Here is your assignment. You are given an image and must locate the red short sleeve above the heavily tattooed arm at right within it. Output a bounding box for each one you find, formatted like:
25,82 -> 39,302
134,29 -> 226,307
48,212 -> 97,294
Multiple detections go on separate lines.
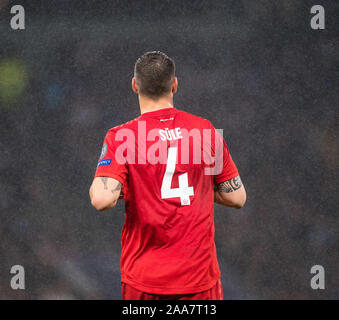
214,126 -> 239,184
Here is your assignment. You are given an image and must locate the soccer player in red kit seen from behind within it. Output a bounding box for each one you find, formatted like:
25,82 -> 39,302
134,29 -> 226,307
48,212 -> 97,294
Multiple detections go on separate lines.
90,51 -> 246,300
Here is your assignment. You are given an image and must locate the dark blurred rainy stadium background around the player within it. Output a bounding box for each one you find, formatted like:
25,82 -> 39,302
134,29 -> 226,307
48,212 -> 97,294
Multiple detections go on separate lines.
0,0 -> 339,299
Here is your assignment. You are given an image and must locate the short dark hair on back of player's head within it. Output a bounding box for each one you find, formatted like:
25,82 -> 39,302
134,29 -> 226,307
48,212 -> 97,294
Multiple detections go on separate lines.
134,51 -> 175,98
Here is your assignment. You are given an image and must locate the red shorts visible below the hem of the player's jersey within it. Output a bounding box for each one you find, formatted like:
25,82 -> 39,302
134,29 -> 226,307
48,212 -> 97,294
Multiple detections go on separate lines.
121,279 -> 223,300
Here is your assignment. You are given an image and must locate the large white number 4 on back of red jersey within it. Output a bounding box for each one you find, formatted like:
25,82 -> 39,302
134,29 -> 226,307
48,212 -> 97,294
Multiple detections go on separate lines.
161,147 -> 194,206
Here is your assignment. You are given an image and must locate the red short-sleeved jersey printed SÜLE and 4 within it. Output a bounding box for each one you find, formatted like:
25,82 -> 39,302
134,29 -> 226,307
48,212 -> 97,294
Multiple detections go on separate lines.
95,108 -> 238,295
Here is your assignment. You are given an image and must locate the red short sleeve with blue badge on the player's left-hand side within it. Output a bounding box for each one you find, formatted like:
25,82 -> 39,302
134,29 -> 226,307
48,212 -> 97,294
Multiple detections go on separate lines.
94,131 -> 128,184
